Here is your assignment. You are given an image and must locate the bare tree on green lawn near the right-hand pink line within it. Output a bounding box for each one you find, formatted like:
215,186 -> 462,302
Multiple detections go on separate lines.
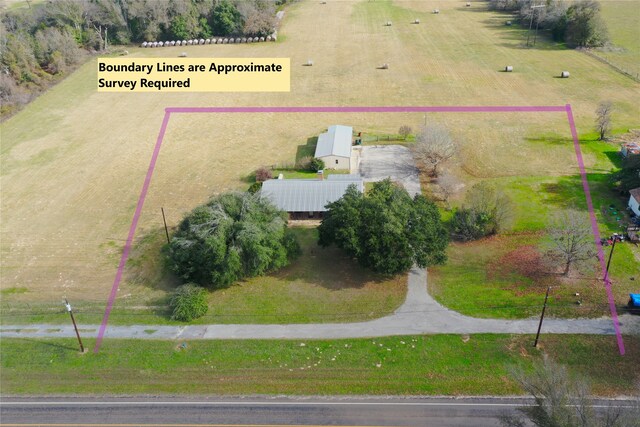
548,211 -> 596,276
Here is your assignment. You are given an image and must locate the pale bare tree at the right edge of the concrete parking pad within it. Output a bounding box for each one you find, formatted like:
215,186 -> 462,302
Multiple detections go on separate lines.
413,124 -> 457,176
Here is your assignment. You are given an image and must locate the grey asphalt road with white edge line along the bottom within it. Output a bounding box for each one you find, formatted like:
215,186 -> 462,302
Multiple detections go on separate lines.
0,396 -> 631,427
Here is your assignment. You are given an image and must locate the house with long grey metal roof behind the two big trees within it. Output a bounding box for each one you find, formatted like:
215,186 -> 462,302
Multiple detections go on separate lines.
260,175 -> 364,219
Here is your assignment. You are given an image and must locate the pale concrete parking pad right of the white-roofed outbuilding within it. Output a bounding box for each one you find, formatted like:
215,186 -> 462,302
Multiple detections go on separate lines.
359,145 -> 420,196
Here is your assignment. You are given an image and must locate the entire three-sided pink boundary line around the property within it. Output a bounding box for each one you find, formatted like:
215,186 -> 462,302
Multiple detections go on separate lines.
93,104 -> 625,355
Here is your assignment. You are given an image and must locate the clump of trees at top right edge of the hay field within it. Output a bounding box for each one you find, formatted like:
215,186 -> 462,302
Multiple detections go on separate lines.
489,0 -> 609,47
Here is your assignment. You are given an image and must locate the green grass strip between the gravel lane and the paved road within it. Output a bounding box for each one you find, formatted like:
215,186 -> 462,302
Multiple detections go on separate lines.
0,335 -> 640,396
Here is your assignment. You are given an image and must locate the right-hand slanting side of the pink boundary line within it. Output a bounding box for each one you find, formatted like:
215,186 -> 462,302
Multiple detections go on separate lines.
565,104 -> 625,355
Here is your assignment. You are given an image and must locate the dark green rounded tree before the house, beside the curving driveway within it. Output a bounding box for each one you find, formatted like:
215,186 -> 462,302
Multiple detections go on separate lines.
318,179 -> 448,274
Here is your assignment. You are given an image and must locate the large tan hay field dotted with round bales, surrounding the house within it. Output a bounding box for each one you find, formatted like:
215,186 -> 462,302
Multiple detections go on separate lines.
0,1 -> 640,316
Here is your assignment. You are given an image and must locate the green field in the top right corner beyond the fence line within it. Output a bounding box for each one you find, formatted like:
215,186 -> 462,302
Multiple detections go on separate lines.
598,0 -> 640,77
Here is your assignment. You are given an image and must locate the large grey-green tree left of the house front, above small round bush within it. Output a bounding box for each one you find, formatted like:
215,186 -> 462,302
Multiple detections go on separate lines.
168,193 -> 299,288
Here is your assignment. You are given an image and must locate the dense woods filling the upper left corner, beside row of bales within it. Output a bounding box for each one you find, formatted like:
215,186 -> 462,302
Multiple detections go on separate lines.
0,0 -> 287,116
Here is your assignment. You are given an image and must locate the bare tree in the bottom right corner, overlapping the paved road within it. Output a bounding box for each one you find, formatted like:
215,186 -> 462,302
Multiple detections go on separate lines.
500,356 -> 640,427
